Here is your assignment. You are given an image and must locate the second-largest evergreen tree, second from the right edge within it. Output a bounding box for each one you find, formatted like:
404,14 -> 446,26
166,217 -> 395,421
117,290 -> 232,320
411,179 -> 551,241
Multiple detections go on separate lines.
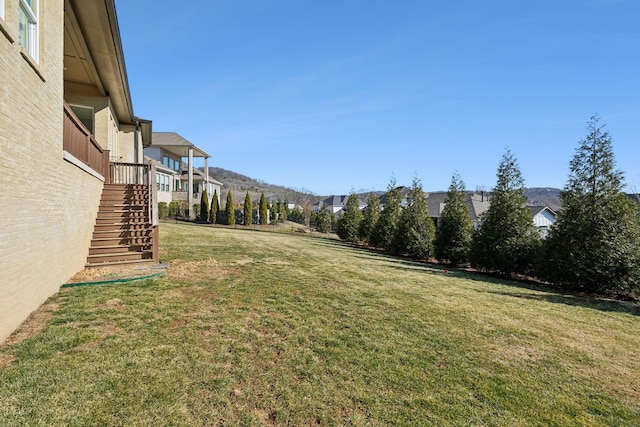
470,150 -> 540,276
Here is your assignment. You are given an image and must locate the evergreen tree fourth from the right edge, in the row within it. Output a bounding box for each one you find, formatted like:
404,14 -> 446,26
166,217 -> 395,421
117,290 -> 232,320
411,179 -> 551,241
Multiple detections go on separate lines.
393,177 -> 436,258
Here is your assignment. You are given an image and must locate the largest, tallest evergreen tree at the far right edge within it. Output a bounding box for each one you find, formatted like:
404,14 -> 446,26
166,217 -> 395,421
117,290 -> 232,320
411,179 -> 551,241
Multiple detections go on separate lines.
540,117 -> 640,294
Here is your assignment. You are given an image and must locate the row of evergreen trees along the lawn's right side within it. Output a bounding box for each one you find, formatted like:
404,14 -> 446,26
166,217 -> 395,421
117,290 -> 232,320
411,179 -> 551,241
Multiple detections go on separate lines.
337,117 -> 640,295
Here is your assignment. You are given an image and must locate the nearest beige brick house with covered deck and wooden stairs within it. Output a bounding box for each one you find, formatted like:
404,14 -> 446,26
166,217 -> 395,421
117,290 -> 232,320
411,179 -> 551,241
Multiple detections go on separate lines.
0,0 -> 157,342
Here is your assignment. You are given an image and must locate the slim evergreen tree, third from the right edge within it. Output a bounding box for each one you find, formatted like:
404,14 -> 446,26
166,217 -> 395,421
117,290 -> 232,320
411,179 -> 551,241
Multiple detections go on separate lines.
435,173 -> 473,265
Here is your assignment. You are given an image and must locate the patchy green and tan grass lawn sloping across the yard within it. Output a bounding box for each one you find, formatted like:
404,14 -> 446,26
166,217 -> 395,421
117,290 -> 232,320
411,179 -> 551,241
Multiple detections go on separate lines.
0,223 -> 640,426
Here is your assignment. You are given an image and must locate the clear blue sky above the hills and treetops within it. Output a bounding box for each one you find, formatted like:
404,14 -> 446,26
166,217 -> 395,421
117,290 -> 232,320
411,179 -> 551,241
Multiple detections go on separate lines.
116,0 -> 640,195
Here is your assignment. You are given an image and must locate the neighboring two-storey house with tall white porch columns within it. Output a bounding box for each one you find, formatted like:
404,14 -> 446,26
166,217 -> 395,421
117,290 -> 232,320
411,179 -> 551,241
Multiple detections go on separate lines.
144,132 -> 222,218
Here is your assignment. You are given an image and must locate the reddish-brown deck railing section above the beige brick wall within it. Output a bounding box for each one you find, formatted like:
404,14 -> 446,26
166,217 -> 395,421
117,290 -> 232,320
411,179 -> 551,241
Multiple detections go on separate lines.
62,102 -> 109,179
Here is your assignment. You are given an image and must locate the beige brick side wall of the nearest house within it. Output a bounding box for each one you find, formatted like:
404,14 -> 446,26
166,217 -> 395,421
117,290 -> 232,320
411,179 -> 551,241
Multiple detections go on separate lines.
0,0 -> 103,342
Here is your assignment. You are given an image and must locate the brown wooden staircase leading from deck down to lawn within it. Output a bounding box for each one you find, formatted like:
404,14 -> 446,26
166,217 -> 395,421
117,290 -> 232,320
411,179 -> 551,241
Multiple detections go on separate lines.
87,184 -> 158,267
